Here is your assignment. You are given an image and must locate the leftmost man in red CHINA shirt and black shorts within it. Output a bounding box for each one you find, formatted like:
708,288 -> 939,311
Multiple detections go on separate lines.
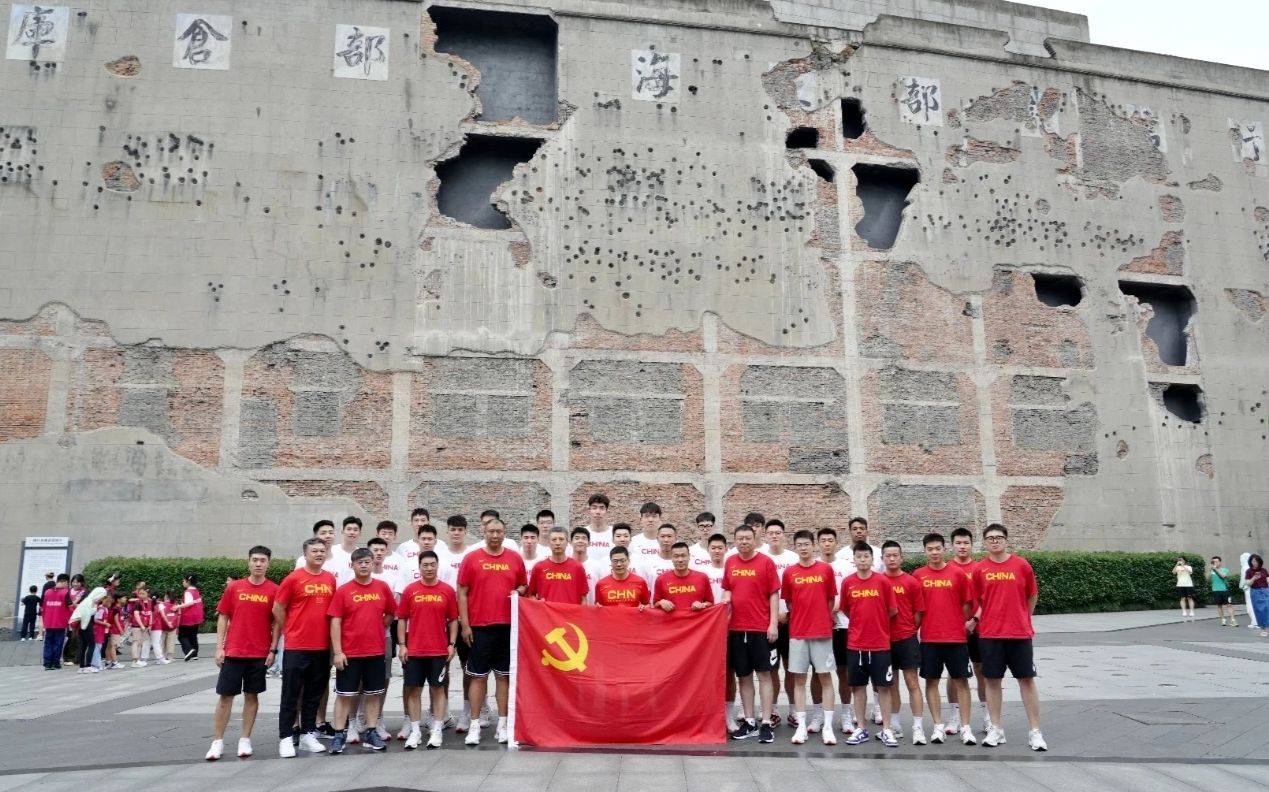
206,545 -> 280,762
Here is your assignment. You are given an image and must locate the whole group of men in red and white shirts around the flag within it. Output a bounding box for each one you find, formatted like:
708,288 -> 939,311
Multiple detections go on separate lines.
206,494 -> 1047,760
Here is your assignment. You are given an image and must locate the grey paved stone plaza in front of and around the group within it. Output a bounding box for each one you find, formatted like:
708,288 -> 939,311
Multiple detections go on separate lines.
0,611 -> 1269,792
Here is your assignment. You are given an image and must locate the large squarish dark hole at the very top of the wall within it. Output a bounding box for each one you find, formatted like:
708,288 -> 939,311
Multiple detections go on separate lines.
428,5 -> 556,124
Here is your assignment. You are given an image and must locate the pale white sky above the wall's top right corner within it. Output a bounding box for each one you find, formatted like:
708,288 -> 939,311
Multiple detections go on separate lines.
1040,0 -> 1269,70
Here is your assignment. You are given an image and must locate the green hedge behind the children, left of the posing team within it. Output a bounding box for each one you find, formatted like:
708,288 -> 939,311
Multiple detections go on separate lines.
84,556 -> 294,632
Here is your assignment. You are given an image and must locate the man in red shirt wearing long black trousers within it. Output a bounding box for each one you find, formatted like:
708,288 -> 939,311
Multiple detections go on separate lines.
273,537 -> 335,759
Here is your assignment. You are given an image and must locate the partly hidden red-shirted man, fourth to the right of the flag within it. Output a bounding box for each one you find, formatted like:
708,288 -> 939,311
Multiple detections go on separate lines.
881,539 -> 925,745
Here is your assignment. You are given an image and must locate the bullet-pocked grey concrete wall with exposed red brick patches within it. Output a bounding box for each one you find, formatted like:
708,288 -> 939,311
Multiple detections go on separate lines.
0,0 -> 1269,611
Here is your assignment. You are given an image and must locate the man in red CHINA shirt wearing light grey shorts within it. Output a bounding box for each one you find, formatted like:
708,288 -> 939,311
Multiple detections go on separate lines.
780,529 -> 838,745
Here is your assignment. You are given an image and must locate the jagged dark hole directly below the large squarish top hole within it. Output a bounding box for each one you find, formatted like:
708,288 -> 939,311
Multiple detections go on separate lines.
437,135 -> 542,228
